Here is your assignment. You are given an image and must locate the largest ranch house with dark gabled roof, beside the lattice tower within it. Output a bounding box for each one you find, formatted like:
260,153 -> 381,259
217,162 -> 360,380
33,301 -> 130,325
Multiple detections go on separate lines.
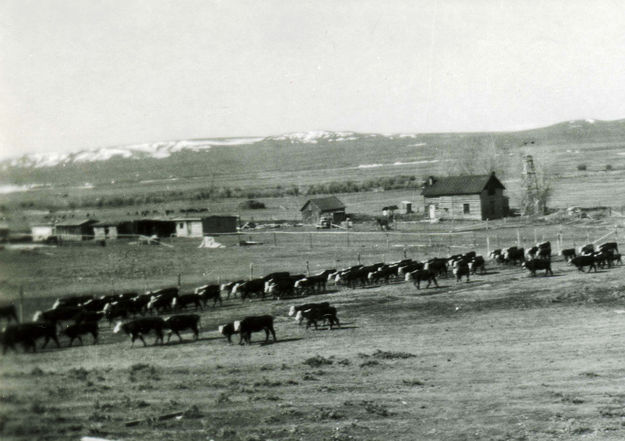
421,173 -> 508,220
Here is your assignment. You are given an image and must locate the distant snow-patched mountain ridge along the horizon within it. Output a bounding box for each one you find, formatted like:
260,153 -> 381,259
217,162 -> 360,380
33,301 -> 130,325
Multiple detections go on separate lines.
0,119 -> 625,184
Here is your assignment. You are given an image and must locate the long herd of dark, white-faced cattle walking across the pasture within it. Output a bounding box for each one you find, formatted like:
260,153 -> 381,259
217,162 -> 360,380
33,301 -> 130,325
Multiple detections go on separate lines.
0,242 -> 622,353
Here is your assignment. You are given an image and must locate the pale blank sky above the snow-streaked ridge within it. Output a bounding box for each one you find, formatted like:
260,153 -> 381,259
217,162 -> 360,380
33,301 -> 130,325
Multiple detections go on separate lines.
0,0 -> 625,157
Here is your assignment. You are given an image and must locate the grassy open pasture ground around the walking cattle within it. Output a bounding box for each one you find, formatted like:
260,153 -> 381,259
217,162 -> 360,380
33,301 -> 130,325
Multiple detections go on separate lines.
0,223 -> 625,441
